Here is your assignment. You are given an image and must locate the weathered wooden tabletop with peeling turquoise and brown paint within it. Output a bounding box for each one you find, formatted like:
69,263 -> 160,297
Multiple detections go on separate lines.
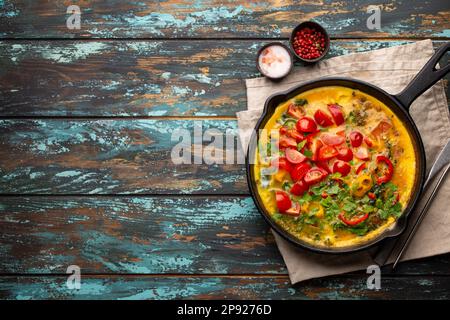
0,0 -> 450,299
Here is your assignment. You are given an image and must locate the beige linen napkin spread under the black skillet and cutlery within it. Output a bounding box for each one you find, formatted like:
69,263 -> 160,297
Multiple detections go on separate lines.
237,40 -> 450,283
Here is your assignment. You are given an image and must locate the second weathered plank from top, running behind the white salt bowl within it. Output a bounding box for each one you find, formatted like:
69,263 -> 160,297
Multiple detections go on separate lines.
0,40 -> 450,117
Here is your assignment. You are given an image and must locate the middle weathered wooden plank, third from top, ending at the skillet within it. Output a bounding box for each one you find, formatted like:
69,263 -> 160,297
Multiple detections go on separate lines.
0,120 -> 248,194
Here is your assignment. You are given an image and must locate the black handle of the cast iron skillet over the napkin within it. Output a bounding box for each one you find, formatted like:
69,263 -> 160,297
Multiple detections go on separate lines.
395,42 -> 450,110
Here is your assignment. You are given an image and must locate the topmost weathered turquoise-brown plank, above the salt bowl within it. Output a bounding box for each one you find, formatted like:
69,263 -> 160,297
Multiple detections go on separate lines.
0,0 -> 450,38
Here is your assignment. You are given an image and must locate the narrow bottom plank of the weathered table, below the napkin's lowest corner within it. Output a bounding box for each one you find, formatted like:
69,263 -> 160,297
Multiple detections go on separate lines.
0,275 -> 450,300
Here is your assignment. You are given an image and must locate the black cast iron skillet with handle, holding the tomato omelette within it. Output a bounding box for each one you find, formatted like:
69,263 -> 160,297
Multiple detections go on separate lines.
246,43 -> 450,253
